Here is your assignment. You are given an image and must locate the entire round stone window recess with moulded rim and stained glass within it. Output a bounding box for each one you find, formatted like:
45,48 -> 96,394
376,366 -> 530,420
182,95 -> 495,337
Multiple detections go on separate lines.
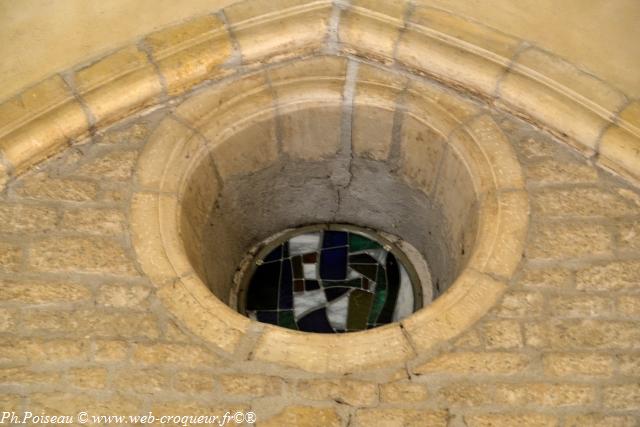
131,57 -> 529,373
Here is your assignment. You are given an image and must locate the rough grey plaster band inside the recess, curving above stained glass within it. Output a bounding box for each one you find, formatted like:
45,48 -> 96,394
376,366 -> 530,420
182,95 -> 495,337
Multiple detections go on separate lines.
199,159 -> 460,308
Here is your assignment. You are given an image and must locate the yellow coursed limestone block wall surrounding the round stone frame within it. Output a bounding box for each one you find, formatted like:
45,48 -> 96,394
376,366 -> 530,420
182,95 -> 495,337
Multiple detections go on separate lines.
0,84 -> 640,426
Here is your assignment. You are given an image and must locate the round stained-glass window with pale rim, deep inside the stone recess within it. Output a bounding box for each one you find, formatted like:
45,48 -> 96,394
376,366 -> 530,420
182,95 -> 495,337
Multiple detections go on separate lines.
238,224 -> 423,333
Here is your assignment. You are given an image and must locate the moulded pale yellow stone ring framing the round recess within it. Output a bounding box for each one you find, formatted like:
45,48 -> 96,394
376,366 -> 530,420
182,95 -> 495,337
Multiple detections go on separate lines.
130,57 -> 529,373
